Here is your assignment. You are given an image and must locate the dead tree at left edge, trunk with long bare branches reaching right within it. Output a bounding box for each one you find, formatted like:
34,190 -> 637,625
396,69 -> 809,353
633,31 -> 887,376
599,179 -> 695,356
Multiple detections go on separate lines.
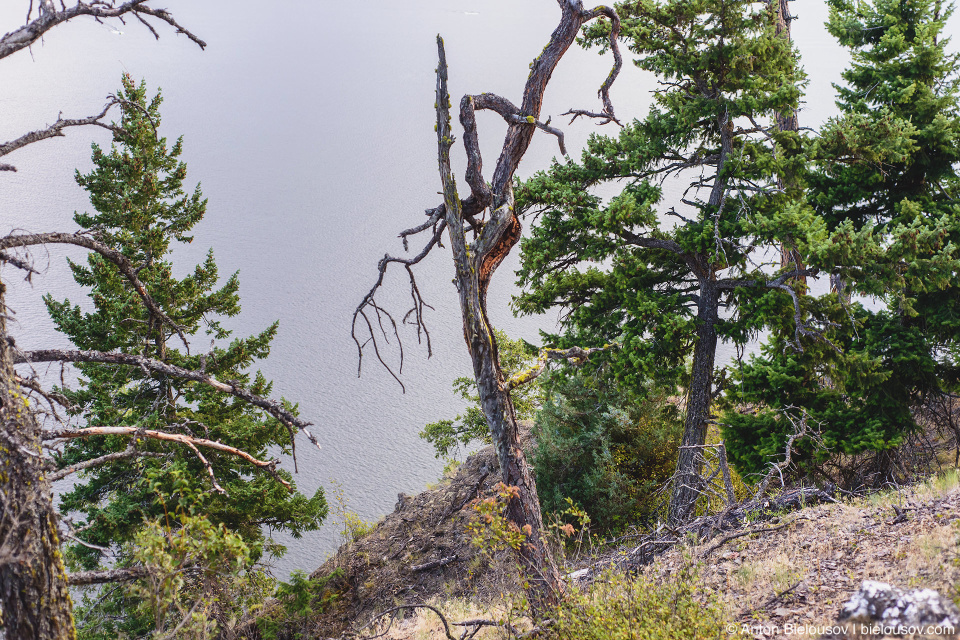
0,6 -> 318,640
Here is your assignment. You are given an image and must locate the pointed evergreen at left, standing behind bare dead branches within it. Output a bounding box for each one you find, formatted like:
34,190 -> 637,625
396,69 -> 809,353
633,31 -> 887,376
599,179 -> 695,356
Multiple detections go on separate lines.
45,76 -> 327,637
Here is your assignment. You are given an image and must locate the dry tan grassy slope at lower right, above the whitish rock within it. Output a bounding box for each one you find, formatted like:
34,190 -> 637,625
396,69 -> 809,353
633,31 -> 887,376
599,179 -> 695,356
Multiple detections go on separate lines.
646,470 -> 960,637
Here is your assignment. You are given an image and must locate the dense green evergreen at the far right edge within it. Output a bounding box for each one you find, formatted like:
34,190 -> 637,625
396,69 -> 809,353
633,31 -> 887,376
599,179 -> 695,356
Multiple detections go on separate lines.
723,0 -> 960,482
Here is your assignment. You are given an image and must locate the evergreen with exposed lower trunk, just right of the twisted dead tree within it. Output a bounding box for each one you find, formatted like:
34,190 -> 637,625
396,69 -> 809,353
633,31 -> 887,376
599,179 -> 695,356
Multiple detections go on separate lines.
516,0 -> 822,520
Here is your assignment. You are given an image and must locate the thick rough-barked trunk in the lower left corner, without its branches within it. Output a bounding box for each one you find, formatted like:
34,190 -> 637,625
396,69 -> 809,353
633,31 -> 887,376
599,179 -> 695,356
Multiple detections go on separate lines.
0,282 -> 76,640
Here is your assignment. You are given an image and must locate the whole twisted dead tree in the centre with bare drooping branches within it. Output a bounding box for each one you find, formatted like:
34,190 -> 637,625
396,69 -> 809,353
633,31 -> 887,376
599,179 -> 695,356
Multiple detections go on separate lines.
353,0 -> 621,611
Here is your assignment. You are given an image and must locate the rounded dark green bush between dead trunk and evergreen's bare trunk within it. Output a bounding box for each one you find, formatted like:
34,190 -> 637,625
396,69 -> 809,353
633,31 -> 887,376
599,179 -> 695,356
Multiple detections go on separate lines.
532,374 -> 683,533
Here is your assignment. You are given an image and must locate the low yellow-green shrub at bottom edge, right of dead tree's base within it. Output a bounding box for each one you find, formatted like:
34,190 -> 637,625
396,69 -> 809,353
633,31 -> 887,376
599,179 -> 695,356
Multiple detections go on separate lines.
542,565 -> 743,640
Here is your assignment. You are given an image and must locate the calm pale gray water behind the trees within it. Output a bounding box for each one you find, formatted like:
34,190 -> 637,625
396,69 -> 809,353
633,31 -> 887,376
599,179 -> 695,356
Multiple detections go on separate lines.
0,0 -> 928,575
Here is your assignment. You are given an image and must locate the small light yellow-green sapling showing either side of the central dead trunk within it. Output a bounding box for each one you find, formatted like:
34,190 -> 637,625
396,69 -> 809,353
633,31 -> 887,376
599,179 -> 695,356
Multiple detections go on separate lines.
420,329 -> 541,458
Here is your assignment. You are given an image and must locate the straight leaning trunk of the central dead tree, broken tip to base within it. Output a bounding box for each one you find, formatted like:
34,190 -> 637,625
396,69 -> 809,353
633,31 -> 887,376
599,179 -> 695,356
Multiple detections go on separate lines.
437,38 -> 563,612
